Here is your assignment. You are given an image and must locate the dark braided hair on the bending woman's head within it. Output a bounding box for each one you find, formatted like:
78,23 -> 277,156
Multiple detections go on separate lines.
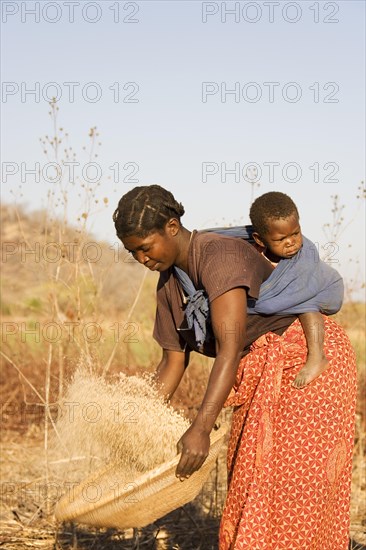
113,185 -> 184,239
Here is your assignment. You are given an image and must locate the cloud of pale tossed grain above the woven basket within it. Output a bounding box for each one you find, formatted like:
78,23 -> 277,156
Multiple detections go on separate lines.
54,368 -> 189,481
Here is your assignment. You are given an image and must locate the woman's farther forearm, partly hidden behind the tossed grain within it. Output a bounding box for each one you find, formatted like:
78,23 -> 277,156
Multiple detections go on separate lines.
154,349 -> 189,400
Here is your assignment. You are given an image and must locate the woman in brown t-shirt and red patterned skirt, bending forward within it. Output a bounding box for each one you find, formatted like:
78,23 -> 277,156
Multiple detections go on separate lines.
113,185 -> 356,550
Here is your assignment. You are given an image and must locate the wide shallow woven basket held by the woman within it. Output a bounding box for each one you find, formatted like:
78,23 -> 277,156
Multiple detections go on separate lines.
55,424 -> 228,529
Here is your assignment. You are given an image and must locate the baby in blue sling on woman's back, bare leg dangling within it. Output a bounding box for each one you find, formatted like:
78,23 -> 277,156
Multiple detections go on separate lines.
249,191 -> 343,388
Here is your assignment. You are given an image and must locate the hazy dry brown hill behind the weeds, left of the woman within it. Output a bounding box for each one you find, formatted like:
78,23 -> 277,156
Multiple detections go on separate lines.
0,205 -> 149,320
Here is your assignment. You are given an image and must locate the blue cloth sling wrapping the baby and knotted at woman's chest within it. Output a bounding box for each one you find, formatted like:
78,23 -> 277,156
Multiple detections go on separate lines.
174,226 -> 344,347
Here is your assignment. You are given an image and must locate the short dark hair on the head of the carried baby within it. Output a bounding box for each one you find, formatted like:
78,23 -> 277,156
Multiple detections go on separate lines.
249,191 -> 299,236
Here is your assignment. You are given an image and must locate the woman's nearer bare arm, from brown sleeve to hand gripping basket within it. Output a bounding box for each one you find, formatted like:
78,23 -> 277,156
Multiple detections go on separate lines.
176,288 -> 247,479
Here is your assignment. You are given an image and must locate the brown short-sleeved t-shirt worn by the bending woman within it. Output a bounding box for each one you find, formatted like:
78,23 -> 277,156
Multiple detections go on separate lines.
153,231 -> 296,357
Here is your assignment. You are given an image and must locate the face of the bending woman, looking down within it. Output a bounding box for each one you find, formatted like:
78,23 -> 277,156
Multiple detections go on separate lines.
122,224 -> 178,271
